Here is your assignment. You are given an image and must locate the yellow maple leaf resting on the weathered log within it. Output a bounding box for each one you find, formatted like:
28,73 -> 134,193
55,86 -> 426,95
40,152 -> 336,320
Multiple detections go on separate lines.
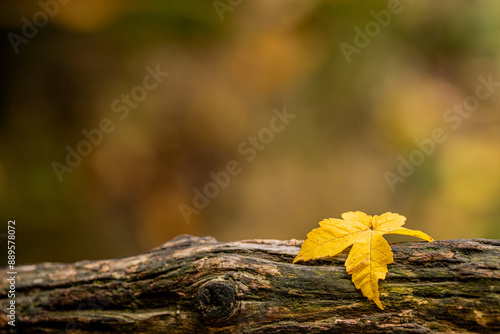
293,211 -> 434,310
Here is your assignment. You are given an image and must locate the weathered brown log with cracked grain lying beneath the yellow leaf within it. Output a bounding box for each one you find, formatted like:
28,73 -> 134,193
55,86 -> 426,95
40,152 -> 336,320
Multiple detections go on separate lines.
0,236 -> 500,333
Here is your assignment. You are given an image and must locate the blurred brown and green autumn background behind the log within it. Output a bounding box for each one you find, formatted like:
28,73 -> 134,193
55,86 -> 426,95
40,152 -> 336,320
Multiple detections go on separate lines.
0,0 -> 500,264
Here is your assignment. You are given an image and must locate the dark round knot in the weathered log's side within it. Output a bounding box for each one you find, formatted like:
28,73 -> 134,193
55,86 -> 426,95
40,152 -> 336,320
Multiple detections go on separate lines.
198,280 -> 235,322
